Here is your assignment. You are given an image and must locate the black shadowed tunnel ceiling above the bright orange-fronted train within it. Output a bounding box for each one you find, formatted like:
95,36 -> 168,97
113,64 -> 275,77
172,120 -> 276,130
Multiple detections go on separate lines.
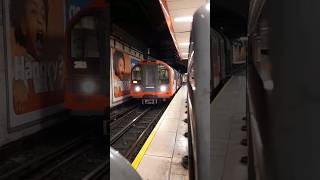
110,0 -> 185,70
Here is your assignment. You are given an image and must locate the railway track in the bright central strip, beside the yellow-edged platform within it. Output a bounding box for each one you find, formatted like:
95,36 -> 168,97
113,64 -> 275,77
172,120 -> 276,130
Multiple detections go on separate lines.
110,103 -> 168,161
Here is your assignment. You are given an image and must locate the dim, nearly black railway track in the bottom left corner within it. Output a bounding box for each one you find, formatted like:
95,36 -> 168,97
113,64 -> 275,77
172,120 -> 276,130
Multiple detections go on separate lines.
0,121 -> 109,180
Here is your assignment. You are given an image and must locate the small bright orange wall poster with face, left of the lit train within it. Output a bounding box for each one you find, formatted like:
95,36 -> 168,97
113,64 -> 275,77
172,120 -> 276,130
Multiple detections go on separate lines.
111,48 -> 131,102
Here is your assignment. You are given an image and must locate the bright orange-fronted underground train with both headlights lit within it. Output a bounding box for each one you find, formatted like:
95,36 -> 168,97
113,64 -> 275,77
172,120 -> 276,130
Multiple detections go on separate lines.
130,60 -> 182,104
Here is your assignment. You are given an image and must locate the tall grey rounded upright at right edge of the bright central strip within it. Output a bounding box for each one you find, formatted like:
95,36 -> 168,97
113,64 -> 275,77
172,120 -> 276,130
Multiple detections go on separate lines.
187,3 -> 211,180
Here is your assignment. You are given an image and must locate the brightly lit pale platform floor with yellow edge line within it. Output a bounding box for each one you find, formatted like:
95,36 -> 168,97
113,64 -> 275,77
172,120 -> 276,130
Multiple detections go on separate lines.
133,85 -> 188,180
